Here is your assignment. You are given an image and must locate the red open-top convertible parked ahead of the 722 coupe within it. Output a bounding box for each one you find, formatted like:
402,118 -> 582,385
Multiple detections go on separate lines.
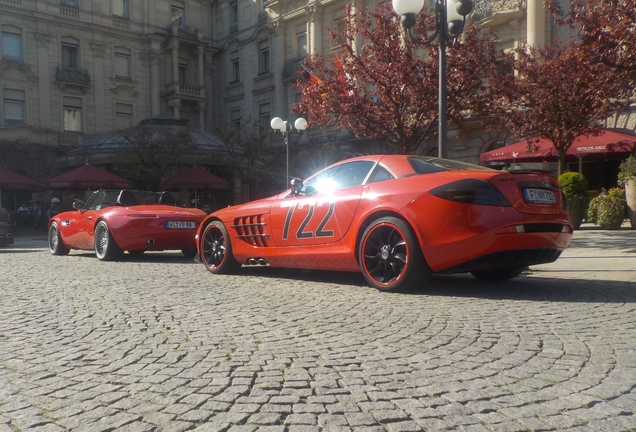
49,189 -> 205,261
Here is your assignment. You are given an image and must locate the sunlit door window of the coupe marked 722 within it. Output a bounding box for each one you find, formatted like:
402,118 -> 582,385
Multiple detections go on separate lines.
300,161 -> 375,195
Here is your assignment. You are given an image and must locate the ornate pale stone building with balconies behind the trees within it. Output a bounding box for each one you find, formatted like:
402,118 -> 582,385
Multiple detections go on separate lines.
0,0 -> 636,187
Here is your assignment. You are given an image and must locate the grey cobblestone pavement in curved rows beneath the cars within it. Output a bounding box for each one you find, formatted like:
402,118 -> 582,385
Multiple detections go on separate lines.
0,224 -> 636,432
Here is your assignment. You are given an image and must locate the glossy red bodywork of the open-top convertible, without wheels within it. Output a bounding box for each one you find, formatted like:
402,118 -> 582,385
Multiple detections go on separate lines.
49,191 -> 206,255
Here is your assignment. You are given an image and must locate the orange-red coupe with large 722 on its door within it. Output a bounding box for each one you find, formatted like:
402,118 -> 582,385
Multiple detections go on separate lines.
196,155 -> 572,291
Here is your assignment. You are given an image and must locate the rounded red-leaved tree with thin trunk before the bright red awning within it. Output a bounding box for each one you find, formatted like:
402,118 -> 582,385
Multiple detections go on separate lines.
490,42 -> 622,175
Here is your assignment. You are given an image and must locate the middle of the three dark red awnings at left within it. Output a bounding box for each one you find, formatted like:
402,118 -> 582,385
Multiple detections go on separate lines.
46,164 -> 132,189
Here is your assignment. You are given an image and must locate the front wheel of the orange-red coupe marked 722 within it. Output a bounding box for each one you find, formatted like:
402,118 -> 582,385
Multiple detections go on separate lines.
200,221 -> 241,274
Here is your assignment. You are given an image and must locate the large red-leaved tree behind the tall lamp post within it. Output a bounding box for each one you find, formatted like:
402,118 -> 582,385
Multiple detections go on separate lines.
292,2 -> 499,154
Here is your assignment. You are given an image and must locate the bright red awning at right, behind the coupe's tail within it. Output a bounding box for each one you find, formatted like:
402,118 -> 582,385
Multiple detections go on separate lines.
479,130 -> 636,162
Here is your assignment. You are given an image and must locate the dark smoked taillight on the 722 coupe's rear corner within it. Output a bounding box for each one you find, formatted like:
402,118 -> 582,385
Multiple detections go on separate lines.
430,179 -> 512,207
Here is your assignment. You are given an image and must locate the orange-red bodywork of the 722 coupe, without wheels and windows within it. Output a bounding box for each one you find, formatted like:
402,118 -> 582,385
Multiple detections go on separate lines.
197,155 -> 572,272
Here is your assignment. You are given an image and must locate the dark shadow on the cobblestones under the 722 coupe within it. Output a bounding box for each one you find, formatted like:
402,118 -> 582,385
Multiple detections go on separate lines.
238,267 -> 636,304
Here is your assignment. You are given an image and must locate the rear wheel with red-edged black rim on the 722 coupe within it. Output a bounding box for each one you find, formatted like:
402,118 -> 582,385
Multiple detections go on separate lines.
358,216 -> 432,292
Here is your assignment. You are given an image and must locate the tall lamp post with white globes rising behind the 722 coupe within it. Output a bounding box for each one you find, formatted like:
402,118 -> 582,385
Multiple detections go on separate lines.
393,0 -> 474,158
